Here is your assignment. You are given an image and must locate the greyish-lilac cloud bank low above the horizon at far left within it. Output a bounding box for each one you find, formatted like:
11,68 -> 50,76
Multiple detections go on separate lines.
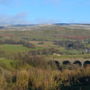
0,12 -> 30,25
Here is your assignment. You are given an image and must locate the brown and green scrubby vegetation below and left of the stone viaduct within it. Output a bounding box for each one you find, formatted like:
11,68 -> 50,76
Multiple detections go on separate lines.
0,46 -> 90,90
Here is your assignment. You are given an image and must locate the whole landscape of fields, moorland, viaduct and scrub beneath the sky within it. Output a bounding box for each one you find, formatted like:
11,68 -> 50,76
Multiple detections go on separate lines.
0,25 -> 90,90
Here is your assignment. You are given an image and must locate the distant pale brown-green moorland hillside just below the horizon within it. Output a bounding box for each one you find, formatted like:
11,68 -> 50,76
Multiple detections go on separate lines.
0,25 -> 90,41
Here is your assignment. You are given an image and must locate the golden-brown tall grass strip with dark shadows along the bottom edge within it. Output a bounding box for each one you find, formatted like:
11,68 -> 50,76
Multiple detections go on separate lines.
0,65 -> 90,90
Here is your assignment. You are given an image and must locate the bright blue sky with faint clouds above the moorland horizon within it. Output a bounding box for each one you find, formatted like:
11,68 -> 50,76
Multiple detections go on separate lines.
0,0 -> 90,24
